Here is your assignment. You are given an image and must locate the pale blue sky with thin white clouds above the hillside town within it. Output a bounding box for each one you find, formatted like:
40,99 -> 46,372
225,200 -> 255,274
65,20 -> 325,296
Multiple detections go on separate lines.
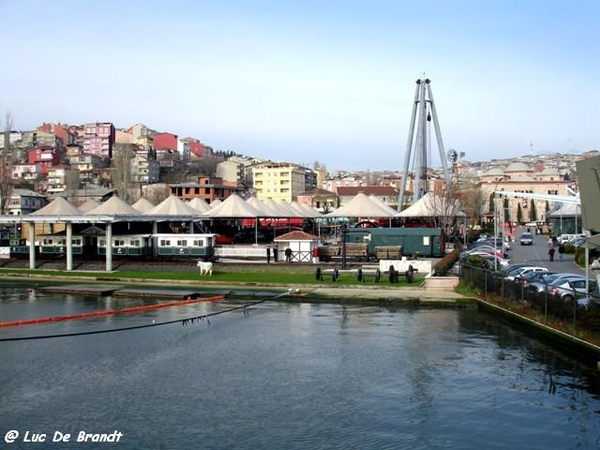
0,0 -> 600,171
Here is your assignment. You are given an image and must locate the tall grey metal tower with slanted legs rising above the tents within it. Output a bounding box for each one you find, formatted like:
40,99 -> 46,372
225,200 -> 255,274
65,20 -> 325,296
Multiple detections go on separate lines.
398,78 -> 451,211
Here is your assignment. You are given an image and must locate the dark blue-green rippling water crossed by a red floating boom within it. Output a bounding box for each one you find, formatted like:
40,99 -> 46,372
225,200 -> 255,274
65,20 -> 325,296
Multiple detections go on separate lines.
0,288 -> 600,450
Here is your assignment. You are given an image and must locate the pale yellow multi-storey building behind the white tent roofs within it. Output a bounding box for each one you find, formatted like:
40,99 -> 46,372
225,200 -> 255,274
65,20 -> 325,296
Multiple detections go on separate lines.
252,162 -> 306,202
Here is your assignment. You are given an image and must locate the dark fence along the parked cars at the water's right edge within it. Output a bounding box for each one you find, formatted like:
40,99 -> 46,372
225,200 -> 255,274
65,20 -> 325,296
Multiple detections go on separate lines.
459,264 -> 600,332
